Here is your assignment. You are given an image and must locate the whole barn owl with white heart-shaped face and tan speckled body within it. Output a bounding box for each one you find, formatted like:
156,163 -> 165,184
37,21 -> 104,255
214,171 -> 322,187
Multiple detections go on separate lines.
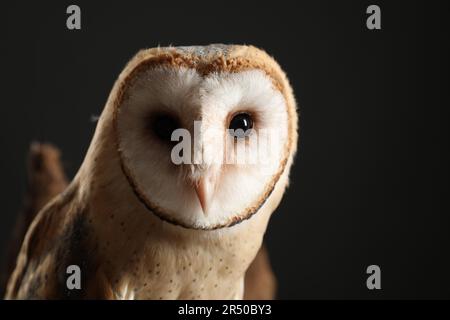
6,45 -> 298,299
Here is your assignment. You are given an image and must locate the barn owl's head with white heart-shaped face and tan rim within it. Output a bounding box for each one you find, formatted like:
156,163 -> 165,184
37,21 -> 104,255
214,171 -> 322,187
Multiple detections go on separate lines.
89,45 -> 297,230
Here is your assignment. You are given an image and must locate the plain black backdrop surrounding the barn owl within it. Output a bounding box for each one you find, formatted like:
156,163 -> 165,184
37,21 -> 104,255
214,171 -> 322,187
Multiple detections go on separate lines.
0,0 -> 450,298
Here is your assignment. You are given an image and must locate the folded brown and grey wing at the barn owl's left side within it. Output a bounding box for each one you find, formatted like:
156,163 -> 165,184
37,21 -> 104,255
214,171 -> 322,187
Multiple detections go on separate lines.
6,184 -> 114,299
